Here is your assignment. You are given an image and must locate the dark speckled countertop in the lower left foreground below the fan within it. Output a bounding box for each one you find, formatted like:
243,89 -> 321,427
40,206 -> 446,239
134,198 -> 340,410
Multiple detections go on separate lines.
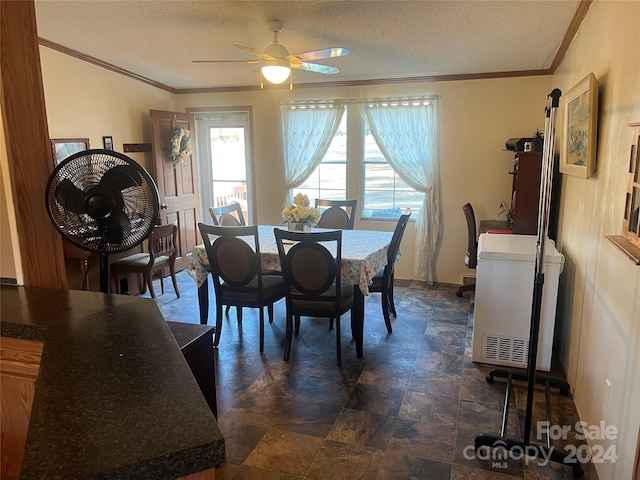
0,286 -> 225,480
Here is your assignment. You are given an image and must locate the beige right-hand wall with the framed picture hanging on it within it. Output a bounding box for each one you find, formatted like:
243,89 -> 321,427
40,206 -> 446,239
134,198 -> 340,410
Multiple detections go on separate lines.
553,1 -> 640,479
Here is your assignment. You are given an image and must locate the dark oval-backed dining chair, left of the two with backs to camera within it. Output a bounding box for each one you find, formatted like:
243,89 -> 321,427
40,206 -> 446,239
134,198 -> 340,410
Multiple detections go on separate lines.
198,223 -> 284,353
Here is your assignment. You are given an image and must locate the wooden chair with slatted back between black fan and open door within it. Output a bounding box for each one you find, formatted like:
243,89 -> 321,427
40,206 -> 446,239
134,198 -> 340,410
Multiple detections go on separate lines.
109,223 -> 180,298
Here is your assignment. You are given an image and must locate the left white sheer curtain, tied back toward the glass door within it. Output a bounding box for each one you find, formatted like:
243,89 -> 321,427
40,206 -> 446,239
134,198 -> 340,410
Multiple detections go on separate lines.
280,102 -> 345,206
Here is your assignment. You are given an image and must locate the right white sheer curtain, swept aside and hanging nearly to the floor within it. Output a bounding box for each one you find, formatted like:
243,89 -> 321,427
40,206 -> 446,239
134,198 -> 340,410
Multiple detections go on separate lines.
362,97 -> 442,284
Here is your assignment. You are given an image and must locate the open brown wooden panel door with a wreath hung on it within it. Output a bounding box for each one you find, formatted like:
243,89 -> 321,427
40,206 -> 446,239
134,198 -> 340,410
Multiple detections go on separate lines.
150,110 -> 200,270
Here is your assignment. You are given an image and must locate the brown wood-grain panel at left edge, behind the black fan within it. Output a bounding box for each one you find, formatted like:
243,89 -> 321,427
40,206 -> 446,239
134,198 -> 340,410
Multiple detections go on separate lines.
0,0 -> 67,288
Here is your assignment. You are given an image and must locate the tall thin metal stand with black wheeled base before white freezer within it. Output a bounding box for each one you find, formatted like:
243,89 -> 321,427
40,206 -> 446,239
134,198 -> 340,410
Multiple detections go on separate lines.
475,88 -> 584,477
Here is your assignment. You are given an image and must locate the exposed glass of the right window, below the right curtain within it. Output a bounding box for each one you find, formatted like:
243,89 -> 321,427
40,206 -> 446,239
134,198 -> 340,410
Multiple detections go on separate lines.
361,120 -> 424,219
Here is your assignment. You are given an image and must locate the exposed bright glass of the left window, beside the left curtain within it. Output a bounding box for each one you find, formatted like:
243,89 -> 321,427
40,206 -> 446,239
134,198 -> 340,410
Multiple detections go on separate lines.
296,115 -> 347,203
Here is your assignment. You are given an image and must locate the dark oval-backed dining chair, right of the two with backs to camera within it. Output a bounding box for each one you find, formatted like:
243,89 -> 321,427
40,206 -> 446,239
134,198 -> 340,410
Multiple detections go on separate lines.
274,228 -> 354,365
